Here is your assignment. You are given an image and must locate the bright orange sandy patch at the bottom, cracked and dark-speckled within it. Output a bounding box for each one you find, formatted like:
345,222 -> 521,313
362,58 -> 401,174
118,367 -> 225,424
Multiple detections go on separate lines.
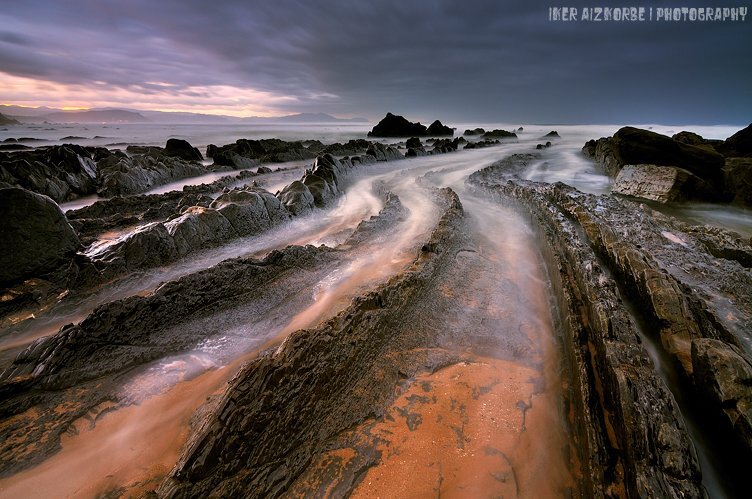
353,358 -> 571,497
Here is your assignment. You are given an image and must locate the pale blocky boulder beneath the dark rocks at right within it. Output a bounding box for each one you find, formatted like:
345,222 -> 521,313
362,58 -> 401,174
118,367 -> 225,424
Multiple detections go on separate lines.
612,165 -> 711,203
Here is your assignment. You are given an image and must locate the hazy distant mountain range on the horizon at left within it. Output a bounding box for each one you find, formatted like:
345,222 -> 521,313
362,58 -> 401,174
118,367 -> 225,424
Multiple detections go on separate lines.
0,105 -> 368,125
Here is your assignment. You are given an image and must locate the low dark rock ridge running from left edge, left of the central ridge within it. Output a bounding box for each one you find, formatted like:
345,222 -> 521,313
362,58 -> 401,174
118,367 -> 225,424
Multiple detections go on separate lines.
0,186 -> 406,476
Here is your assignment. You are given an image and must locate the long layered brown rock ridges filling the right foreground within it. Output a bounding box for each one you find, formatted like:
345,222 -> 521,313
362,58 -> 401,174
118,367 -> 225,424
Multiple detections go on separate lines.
471,158 -> 752,497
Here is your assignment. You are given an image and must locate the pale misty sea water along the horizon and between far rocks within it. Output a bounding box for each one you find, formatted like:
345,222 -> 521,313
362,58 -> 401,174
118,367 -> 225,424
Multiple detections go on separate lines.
0,122 -> 752,237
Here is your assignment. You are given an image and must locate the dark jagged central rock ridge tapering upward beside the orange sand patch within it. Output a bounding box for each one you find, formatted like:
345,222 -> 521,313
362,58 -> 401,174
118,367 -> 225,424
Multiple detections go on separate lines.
157,189 -> 463,497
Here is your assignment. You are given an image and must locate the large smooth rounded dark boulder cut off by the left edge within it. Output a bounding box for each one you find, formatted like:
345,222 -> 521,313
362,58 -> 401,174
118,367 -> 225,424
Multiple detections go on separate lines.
0,187 -> 80,284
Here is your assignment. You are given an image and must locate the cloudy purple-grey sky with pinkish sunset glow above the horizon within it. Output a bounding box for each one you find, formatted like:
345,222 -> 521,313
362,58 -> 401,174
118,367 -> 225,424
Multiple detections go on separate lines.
0,0 -> 752,125
